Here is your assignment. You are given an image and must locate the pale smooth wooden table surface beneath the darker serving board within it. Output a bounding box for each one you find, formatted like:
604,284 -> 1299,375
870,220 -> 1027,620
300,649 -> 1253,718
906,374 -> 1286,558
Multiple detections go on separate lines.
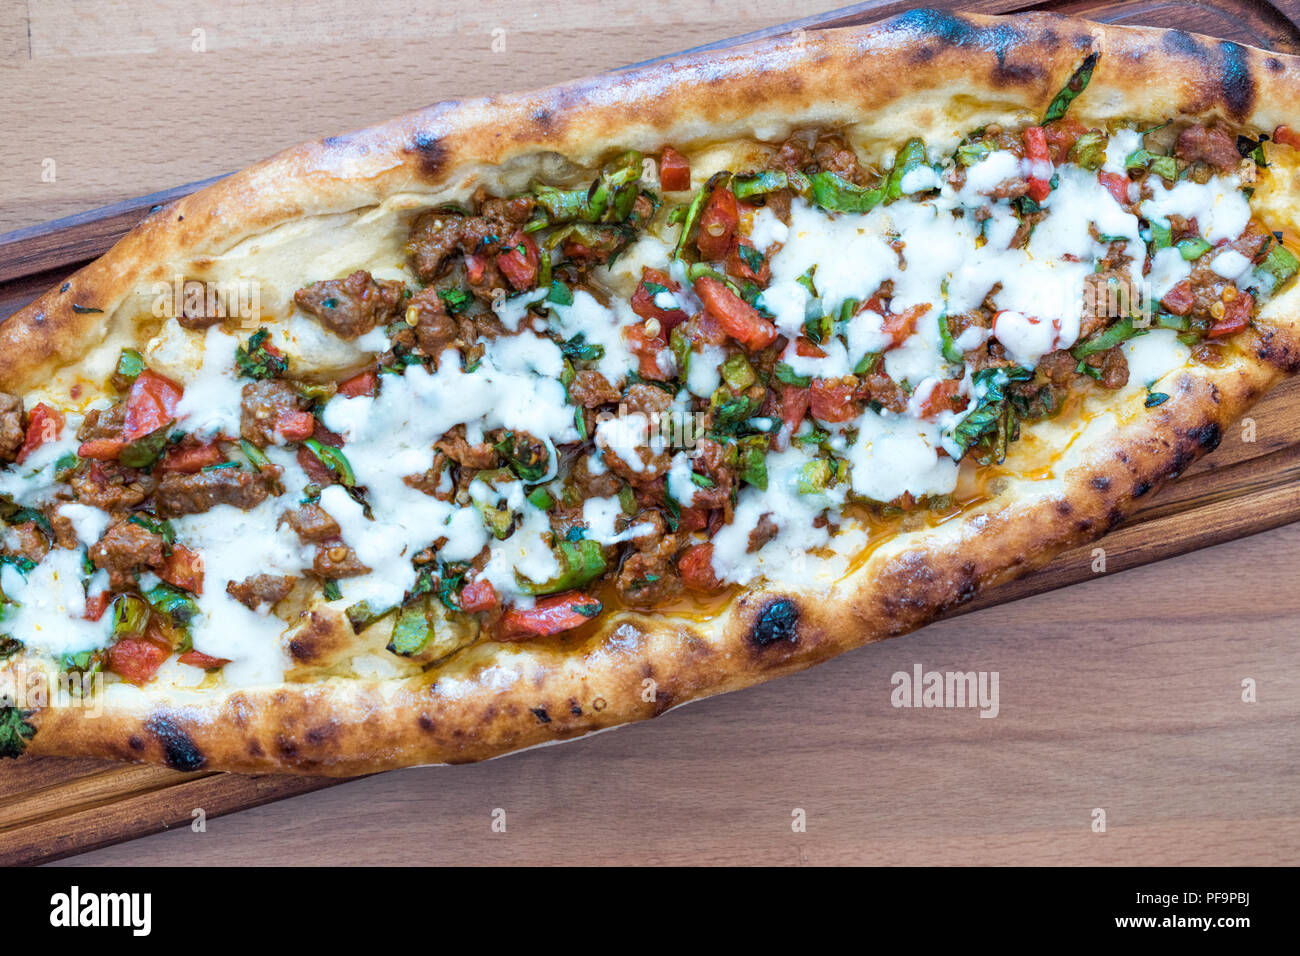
0,0 -> 1300,865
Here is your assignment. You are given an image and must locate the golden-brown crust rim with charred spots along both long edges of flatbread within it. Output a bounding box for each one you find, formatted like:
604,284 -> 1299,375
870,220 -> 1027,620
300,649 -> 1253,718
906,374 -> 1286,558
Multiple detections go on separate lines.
0,12 -> 1300,775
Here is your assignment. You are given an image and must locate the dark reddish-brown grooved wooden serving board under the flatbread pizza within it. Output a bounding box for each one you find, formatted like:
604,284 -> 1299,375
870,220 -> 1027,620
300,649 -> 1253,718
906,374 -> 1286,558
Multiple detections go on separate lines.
0,0 -> 1300,865
